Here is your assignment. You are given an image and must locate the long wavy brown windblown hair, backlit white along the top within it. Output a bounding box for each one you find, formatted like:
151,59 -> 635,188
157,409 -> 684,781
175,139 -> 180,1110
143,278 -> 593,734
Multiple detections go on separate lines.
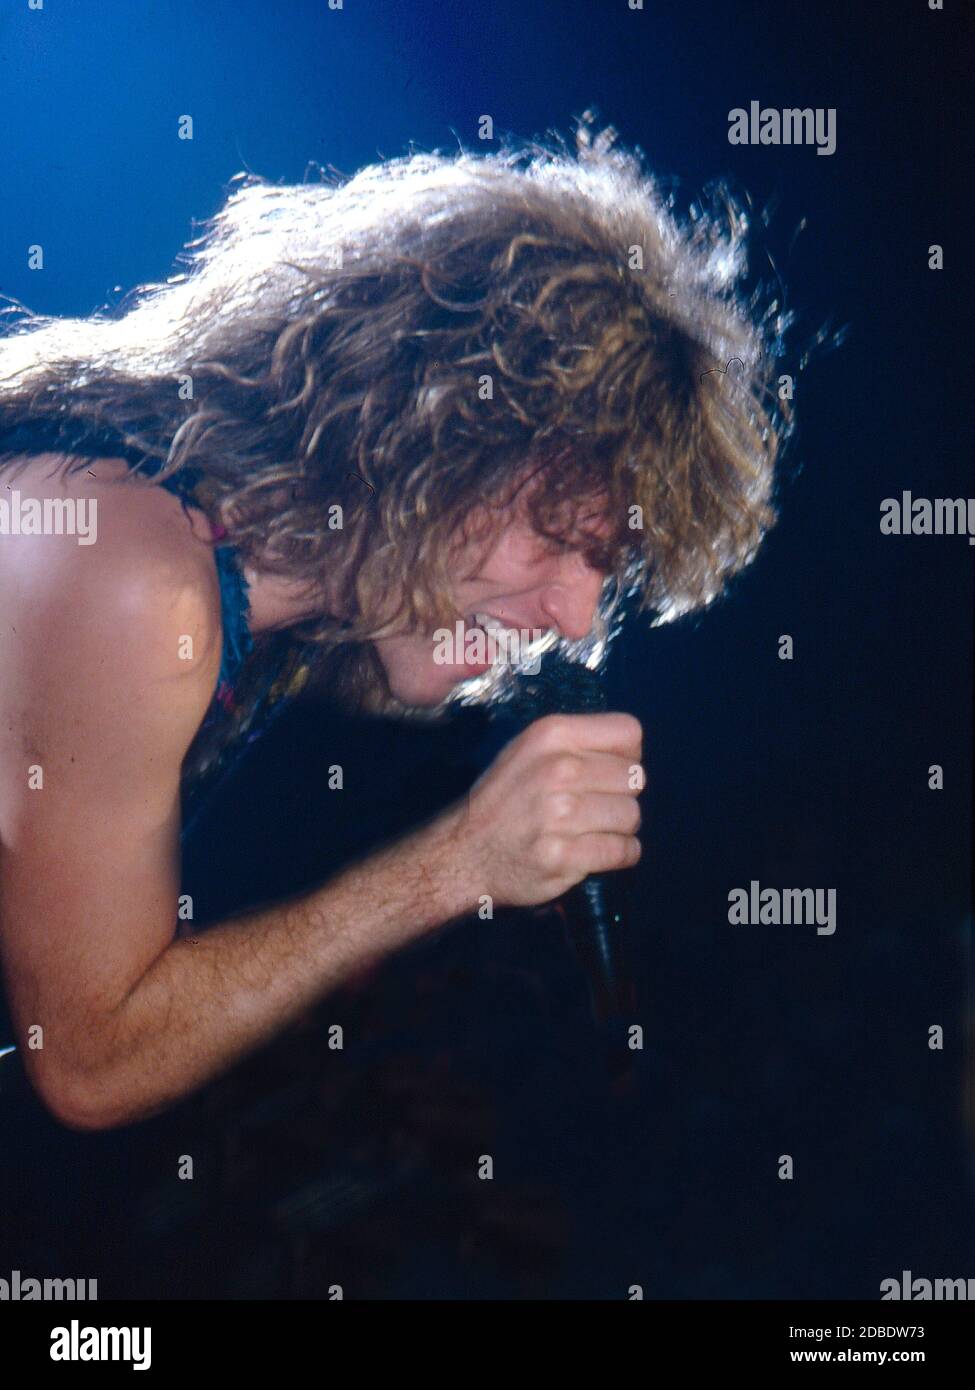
0,113 -> 790,728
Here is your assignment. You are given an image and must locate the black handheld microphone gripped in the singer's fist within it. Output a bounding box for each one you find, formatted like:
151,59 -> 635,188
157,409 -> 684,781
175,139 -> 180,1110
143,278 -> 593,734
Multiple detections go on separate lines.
472,649 -> 636,1023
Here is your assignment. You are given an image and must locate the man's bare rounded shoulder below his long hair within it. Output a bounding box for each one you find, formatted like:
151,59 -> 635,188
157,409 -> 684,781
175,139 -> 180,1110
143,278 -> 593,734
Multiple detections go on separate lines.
0,456 -> 220,767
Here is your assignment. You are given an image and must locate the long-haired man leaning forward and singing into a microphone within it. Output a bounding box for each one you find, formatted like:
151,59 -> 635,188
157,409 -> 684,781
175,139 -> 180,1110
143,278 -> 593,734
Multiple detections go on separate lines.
0,118 -> 789,1129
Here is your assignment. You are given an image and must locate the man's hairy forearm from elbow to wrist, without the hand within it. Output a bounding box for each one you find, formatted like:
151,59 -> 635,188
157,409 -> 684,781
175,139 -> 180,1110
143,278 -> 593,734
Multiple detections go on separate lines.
51,813 -> 476,1129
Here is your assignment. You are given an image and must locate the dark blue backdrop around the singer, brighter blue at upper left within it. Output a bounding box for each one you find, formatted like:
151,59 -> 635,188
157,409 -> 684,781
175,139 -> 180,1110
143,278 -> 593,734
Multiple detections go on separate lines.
0,0 -> 975,1298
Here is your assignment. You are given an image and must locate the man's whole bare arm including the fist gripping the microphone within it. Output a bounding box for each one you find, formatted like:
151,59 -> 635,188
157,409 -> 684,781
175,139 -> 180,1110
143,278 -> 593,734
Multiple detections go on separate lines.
0,461 -> 641,1129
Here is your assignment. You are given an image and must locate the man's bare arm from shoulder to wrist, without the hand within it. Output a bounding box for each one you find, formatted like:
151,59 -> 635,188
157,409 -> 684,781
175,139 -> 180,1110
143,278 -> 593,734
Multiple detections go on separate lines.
0,520 -> 476,1129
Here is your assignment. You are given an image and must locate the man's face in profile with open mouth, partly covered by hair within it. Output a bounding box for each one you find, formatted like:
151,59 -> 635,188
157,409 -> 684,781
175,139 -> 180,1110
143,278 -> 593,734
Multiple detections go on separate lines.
374,486 -> 608,706
